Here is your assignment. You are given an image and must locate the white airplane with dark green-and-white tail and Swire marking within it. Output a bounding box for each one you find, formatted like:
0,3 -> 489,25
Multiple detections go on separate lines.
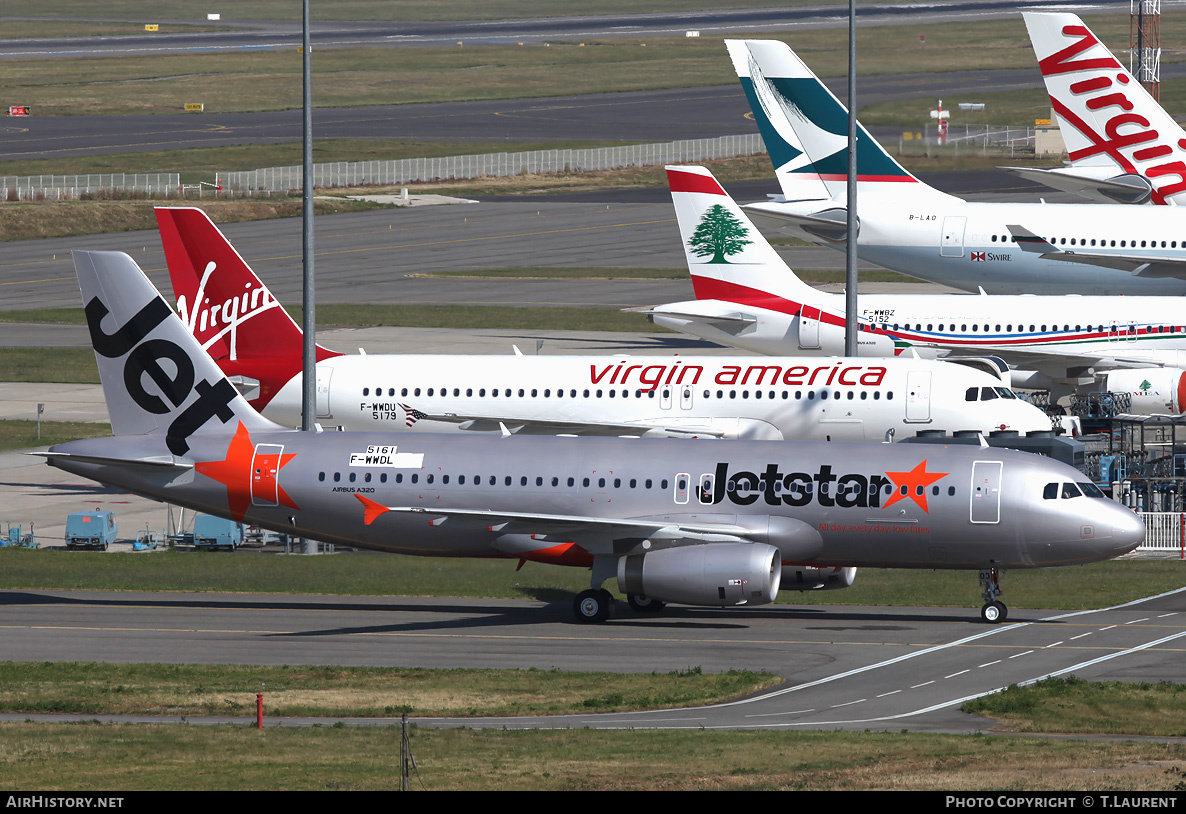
726,40 -> 1186,296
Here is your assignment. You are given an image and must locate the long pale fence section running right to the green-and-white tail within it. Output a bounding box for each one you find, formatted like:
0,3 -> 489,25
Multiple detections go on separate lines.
219,133 -> 766,196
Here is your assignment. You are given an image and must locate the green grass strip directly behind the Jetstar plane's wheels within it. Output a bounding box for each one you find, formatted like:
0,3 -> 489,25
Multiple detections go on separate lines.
0,548 -> 1186,612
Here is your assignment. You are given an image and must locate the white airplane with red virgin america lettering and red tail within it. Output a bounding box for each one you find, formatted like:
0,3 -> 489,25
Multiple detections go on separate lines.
150,208 -> 1051,440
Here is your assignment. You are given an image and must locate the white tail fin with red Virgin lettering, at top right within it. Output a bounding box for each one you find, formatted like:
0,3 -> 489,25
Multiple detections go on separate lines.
1022,12 -> 1186,205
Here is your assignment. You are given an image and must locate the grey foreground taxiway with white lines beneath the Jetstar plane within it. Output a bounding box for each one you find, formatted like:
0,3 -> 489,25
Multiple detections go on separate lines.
0,586 -> 1186,732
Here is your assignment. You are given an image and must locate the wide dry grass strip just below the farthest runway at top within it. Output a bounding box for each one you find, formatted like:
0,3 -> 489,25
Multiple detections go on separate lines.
5,11 -> 1186,123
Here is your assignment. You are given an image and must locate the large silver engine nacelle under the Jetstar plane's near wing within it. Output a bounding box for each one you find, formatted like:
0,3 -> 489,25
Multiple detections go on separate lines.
618,542 -> 783,608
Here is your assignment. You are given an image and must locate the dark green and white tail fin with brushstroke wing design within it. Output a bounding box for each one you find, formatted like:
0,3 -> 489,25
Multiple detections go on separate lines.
726,39 -> 950,201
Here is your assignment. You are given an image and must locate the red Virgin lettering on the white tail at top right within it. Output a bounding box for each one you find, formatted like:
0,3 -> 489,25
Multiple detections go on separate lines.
1039,25 -> 1186,203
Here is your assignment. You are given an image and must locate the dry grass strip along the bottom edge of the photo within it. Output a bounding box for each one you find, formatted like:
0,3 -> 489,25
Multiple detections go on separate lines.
0,724 -> 1186,801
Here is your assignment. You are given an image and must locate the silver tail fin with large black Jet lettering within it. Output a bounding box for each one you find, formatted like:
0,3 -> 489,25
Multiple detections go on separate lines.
74,252 -> 283,456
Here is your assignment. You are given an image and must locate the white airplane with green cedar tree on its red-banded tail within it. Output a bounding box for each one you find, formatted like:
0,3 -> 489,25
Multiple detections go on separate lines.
645,166 -> 1186,413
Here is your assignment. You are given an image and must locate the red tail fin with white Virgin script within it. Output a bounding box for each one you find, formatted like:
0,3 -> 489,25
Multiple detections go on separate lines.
155,208 -> 339,403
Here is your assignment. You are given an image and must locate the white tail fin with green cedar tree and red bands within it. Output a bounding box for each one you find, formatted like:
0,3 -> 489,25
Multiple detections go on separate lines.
667,166 -> 827,305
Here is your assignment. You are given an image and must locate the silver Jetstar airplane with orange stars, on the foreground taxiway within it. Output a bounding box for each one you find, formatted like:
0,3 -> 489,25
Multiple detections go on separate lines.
42,252 -> 1144,622
